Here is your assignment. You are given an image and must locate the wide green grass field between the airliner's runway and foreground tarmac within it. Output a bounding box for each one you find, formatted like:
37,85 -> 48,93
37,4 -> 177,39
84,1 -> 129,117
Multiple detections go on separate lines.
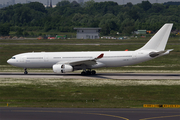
0,78 -> 180,108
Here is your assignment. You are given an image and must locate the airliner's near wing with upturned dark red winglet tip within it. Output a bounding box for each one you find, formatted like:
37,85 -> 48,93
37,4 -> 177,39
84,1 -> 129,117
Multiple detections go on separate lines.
58,53 -> 104,66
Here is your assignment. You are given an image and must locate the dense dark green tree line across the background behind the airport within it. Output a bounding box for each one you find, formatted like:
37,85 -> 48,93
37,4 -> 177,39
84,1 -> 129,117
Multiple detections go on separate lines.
0,0 -> 180,35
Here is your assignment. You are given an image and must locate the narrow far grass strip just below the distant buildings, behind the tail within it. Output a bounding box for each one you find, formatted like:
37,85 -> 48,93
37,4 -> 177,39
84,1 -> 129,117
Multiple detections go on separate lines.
0,37 -> 180,45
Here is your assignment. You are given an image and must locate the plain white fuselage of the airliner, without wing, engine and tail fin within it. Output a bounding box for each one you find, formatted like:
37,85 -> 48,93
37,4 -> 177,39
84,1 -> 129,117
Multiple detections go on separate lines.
7,51 -> 152,68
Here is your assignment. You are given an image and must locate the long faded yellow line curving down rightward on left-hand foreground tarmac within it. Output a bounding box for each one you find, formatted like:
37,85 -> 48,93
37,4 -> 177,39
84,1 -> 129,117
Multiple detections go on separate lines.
12,110 -> 129,120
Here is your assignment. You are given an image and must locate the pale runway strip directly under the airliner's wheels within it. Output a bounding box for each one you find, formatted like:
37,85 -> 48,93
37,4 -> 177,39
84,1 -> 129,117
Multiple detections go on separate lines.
0,72 -> 180,80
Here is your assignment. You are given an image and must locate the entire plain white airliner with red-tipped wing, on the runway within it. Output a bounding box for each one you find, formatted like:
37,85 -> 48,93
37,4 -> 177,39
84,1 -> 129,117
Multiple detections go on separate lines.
7,23 -> 173,75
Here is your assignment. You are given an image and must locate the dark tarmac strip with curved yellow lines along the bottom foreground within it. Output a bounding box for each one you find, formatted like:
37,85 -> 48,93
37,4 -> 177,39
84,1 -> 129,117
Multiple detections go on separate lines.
0,107 -> 180,120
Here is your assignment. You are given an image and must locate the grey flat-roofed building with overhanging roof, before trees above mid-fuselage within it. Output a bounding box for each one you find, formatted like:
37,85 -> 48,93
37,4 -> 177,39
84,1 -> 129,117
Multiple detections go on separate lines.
74,28 -> 101,39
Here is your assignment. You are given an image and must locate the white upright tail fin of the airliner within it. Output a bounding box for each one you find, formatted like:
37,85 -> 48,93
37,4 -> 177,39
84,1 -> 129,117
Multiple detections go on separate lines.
138,23 -> 173,51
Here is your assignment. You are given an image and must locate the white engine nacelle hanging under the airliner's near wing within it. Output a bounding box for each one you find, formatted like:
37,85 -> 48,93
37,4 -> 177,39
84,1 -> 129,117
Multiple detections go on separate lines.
53,64 -> 74,73
